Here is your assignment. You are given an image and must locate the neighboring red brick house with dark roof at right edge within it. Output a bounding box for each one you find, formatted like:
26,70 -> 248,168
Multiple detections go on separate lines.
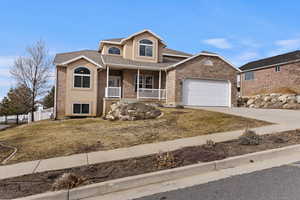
240,51 -> 300,96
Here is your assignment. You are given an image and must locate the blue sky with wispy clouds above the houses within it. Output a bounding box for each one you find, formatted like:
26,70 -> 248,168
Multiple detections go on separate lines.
0,0 -> 300,99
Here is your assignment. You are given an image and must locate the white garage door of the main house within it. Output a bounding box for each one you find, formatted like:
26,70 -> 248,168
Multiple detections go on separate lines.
182,79 -> 230,106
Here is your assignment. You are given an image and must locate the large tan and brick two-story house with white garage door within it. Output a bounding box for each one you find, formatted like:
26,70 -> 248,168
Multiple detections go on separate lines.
54,30 -> 239,118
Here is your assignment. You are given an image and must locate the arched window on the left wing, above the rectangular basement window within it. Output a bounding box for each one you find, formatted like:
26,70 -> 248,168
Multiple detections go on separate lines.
74,67 -> 91,88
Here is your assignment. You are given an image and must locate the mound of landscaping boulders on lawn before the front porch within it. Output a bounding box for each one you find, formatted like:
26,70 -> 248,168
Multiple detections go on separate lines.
105,102 -> 161,121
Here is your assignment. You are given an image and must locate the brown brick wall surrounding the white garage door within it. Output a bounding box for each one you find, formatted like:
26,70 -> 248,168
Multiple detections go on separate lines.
167,56 -> 238,105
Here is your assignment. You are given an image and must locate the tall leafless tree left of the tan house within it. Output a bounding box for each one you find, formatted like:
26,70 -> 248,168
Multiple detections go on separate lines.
10,40 -> 52,121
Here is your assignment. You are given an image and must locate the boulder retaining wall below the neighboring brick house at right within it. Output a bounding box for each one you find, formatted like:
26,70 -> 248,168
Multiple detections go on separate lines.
238,93 -> 300,109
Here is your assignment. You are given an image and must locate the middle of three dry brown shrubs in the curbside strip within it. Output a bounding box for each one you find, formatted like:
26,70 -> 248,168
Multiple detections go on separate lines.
155,152 -> 179,169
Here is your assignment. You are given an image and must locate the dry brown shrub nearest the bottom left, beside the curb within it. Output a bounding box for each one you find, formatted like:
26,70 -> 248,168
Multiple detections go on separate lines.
52,173 -> 86,190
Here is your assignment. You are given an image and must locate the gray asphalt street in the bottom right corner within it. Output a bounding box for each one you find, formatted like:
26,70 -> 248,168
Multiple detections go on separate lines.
136,163 -> 300,200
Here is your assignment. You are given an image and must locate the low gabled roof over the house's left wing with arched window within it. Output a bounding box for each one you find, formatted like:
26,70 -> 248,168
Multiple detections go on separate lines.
54,50 -> 104,68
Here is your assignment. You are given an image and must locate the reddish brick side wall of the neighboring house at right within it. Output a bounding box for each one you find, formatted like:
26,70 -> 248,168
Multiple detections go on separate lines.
241,62 -> 300,96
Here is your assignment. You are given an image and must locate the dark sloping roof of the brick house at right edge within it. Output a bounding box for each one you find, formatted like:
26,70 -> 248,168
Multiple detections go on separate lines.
240,50 -> 300,71
